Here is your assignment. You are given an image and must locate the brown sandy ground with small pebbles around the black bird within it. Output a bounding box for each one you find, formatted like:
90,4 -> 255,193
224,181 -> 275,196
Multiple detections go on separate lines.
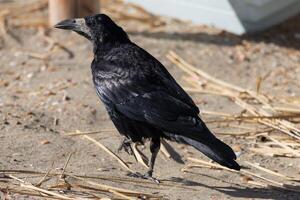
0,0 -> 300,200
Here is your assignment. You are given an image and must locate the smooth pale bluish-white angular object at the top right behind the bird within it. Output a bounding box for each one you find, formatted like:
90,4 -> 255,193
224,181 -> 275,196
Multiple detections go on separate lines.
126,0 -> 300,34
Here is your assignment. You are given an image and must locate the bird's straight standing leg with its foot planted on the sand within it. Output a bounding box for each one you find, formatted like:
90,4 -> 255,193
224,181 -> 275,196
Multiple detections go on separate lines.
129,138 -> 160,183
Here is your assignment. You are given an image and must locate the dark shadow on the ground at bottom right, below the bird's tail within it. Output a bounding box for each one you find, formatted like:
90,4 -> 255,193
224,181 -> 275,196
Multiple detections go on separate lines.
165,172 -> 300,200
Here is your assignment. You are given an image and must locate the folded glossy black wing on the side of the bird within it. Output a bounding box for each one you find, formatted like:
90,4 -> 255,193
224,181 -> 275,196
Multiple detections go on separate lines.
92,56 -> 201,136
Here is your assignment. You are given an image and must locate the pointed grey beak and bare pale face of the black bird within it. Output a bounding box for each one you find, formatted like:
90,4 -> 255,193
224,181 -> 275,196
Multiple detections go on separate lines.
54,18 -> 92,40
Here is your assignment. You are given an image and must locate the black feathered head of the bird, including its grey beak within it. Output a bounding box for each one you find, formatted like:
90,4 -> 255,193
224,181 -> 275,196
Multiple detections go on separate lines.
54,14 -> 129,44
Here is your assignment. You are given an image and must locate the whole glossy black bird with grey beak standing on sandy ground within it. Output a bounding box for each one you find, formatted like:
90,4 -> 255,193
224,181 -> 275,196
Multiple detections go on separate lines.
55,14 -> 240,183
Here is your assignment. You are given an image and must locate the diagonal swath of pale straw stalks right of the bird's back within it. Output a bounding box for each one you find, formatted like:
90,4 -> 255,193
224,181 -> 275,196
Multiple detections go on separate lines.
167,51 -> 300,139
